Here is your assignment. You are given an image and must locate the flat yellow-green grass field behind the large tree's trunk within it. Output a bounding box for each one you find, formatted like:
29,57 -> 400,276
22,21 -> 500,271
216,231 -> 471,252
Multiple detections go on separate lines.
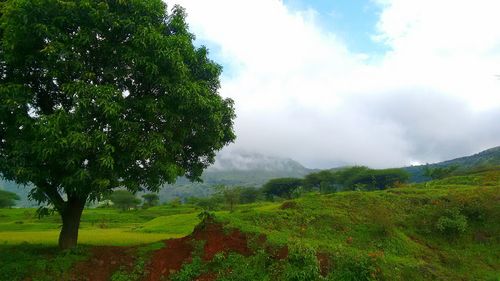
0,203 -> 203,245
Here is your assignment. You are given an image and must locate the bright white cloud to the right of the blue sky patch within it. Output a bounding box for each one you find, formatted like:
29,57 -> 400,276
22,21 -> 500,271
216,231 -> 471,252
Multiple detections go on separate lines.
378,0 -> 500,109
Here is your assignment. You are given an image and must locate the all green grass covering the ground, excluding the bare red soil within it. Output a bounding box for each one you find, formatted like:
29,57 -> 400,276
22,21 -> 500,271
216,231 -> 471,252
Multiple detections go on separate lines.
0,167 -> 500,281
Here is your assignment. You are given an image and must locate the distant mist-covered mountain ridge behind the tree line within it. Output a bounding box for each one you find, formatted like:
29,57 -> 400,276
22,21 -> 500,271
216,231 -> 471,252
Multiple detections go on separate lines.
0,146 -> 500,207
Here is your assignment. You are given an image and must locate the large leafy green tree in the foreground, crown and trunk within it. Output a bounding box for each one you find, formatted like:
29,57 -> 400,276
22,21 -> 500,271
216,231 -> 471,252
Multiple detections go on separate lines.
0,0 -> 235,248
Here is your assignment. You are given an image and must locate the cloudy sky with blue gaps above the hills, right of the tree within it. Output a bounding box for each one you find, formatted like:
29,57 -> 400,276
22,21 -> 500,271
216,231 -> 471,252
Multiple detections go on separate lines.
167,0 -> 500,168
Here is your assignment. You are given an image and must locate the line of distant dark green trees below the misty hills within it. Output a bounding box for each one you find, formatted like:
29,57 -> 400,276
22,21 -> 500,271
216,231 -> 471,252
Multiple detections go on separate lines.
0,166 -> 410,211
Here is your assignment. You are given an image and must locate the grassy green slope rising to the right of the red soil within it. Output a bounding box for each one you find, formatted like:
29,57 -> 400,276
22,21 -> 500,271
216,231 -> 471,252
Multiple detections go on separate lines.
216,172 -> 500,280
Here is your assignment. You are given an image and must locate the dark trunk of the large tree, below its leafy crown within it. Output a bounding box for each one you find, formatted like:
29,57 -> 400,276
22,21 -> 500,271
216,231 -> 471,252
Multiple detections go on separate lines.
59,198 -> 85,250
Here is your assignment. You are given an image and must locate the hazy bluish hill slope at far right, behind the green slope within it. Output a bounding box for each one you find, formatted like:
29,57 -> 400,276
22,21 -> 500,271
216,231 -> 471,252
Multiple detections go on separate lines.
404,146 -> 500,182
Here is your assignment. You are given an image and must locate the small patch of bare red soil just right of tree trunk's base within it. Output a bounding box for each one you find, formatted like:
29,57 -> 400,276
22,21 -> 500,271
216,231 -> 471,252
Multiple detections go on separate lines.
70,246 -> 134,281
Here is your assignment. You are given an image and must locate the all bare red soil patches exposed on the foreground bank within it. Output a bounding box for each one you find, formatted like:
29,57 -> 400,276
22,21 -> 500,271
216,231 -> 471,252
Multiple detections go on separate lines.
66,221 -> 331,281
